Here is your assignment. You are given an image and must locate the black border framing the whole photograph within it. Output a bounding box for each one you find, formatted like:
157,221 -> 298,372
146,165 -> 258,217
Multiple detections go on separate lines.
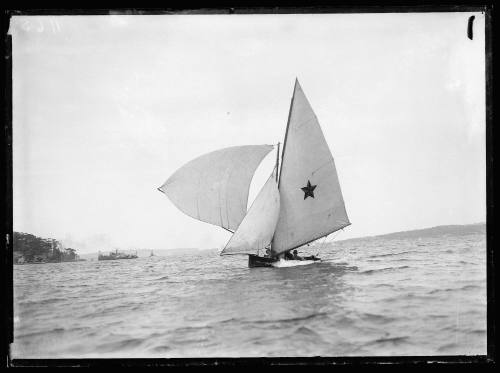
0,5 -> 500,367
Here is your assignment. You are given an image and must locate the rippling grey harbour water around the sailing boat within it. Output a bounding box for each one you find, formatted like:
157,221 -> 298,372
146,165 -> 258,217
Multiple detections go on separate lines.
11,234 -> 486,358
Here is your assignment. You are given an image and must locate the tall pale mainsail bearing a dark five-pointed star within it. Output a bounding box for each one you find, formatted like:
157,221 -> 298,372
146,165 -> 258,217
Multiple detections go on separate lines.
272,80 -> 351,255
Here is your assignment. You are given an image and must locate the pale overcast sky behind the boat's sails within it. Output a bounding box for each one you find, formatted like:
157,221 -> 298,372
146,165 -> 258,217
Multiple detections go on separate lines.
10,12 -> 486,253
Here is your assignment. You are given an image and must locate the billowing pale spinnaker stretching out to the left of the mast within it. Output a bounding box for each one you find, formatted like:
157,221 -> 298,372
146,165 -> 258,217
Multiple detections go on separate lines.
158,145 -> 273,231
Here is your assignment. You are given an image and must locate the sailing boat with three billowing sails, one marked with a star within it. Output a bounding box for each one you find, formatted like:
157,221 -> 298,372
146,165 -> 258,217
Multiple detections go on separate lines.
158,79 -> 351,267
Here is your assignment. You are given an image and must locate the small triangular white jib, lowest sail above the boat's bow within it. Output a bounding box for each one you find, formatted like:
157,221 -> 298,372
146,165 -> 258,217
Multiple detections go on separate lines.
221,169 -> 280,255
